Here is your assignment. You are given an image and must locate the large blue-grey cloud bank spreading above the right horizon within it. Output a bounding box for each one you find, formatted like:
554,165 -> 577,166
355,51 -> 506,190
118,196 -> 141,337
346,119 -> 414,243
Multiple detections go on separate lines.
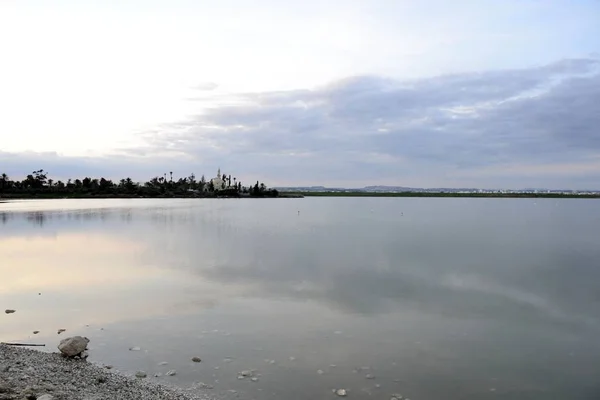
3,58 -> 600,188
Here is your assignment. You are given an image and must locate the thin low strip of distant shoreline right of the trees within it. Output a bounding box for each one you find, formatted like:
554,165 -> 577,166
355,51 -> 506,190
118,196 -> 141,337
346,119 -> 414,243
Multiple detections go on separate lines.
280,191 -> 600,199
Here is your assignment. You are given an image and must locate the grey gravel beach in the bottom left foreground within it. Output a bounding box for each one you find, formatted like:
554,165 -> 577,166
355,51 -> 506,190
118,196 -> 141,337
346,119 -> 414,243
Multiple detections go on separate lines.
0,345 -> 210,400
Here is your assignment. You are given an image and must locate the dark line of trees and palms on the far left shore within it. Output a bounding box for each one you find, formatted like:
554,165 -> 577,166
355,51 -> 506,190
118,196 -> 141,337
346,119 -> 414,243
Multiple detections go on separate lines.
0,169 -> 278,198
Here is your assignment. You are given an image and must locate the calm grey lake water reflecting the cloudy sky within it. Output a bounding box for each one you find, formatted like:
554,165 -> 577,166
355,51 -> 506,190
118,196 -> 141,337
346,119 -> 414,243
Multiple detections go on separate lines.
0,198 -> 600,400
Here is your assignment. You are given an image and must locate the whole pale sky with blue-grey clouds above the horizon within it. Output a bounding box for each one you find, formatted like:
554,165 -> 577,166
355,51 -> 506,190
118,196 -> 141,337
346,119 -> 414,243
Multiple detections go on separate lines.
0,0 -> 600,189
